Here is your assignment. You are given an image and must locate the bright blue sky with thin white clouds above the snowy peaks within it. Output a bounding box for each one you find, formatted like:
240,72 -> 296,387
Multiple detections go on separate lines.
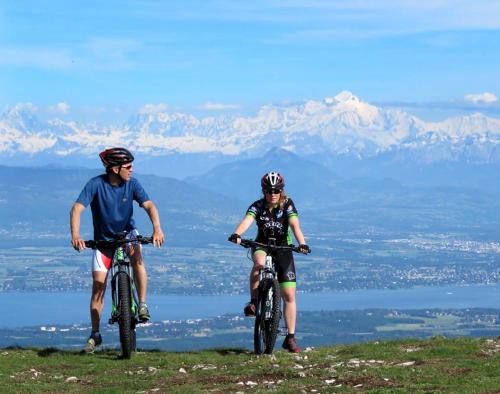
0,0 -> 500,120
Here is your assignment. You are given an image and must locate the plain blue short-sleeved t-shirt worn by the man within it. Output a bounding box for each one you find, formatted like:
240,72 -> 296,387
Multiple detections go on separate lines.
76,174 -> 149,240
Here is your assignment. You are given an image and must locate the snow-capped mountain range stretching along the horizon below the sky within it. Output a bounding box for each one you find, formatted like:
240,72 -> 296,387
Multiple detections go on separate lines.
0,91 -> 500,162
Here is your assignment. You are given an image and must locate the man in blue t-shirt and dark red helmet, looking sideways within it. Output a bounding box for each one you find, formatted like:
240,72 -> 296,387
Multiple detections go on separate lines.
70,148 -> 164,353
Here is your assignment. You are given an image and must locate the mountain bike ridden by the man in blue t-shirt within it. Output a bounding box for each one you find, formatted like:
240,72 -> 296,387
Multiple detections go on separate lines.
85,233 -> 153,358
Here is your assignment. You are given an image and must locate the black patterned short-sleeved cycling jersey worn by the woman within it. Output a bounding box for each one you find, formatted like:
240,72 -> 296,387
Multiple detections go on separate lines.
246,198 -> 298,246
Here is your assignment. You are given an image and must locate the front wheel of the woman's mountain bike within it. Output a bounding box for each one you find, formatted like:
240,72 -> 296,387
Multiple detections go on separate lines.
254,279 -> 280,354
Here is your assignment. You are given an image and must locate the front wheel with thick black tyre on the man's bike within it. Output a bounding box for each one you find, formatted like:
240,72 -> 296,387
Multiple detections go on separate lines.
118,272 -> 135,358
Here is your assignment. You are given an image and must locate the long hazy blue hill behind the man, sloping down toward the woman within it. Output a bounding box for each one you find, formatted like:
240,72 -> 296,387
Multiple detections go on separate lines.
0,166 -> 243,245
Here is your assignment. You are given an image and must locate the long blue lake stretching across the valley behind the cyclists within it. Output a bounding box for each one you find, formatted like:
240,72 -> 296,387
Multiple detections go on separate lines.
0,284 -> 500,328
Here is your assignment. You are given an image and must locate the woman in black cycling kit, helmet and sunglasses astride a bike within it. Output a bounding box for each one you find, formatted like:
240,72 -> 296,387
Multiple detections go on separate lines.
229,172 -> 310,353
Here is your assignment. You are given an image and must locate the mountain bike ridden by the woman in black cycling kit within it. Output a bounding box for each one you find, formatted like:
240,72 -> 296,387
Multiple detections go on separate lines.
235,238 -> 308,354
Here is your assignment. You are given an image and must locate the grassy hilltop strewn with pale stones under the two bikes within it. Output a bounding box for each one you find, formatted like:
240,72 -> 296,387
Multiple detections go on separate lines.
0,337 -> 500,393
